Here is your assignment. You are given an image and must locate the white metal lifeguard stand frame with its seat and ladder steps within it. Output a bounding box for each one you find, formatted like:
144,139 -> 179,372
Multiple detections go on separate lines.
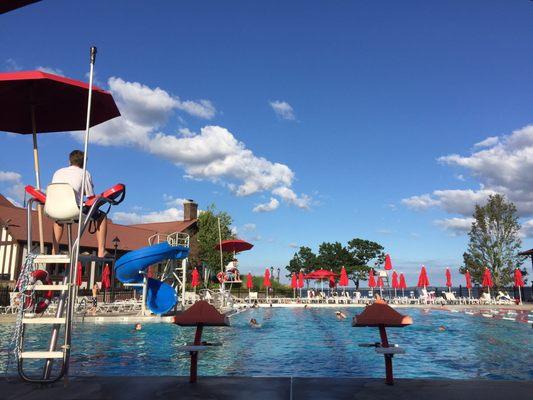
16,183 -> 125,383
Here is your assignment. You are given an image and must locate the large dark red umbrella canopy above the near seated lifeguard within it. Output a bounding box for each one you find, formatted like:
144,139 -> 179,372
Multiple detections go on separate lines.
0,71 -> 120,134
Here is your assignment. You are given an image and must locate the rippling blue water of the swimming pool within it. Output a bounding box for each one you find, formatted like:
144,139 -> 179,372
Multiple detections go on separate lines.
0,308 -> 533,380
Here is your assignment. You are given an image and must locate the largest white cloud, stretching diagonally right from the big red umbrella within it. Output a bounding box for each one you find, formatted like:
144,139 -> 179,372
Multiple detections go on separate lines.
84,78 -> 311,209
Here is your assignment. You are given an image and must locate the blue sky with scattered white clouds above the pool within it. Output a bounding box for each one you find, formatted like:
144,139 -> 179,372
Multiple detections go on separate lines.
0,0 -> 533,284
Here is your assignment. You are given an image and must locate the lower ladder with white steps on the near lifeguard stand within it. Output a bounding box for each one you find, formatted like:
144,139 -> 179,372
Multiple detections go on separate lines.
17,255 -> 75,383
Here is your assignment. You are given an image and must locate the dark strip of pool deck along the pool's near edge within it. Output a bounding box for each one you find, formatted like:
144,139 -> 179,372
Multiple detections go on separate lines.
0,376 -> 533,400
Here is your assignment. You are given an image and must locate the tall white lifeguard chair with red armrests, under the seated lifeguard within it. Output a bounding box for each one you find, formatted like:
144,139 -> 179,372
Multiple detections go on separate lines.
15,183 -> 126,383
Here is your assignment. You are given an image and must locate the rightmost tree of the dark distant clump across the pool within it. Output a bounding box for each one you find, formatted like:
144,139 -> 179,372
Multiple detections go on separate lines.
345,238 -> 385,289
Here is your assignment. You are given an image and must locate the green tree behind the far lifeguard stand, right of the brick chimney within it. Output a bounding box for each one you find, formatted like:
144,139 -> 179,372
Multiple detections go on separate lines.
196,204 -> 234,271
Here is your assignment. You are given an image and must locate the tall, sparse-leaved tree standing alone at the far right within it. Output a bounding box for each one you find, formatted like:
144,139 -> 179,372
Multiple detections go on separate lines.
459,194 -> 524,287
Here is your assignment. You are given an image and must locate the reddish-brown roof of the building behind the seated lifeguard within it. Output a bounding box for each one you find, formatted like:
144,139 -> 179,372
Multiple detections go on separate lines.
0,195 -> 196,250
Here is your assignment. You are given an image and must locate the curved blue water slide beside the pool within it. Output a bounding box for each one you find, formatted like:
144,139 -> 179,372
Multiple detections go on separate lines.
115,242 -> 189,314
